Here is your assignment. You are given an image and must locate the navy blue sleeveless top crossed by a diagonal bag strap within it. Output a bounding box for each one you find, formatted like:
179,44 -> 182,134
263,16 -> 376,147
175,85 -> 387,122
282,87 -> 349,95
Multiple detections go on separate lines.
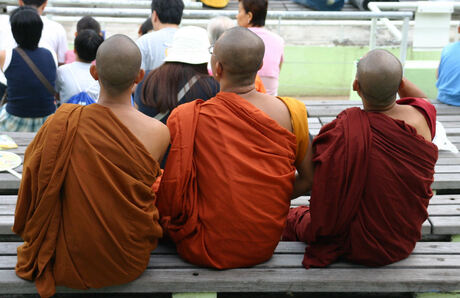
5,48 -> 56,118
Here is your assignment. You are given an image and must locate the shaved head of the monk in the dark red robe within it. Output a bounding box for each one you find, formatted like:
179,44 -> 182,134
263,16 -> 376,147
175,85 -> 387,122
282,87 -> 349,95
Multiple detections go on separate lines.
356,50 -> 403,106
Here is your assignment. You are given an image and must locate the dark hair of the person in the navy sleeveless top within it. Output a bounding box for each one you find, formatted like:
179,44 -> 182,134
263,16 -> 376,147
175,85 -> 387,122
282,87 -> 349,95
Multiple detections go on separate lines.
10,6 -> 43,50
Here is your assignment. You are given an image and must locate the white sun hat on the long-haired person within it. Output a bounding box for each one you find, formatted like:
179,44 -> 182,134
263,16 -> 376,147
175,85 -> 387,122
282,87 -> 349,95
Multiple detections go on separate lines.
164,26 -> 211,64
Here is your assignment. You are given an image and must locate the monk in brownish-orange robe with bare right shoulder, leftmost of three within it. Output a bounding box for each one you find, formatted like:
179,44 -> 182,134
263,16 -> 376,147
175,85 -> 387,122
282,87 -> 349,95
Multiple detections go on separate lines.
13,35 -> 169,297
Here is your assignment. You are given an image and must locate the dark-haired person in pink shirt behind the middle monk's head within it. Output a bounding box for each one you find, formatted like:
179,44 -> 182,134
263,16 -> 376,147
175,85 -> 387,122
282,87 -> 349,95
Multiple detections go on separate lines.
236,0 -> 284,96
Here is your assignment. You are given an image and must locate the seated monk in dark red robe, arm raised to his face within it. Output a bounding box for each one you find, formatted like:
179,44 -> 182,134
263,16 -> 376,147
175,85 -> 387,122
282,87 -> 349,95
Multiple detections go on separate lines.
283,50 -> 438,268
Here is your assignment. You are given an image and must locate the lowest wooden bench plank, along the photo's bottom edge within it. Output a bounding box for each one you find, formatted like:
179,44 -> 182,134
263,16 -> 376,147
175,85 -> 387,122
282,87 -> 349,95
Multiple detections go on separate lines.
0,268 -> 460,294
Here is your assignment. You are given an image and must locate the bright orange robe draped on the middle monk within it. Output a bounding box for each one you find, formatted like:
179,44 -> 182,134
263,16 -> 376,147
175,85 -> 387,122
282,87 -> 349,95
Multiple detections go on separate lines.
157,92 -> 308,269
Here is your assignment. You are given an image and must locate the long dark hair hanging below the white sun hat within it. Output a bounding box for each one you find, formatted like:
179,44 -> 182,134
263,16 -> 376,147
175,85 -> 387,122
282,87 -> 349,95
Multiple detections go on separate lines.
141,62 -> 214,113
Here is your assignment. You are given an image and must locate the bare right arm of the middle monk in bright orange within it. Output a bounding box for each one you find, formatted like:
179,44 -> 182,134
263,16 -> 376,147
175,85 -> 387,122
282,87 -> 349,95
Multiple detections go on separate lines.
291,142 -> 314,199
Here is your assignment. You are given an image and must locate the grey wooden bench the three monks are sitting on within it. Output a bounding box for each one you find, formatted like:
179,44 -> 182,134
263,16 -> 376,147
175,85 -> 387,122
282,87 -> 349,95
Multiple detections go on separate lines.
0,242 -> 460,294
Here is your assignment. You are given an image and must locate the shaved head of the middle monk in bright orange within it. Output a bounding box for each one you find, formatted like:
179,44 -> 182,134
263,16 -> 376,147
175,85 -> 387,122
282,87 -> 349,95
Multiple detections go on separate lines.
214,27 -> 265,85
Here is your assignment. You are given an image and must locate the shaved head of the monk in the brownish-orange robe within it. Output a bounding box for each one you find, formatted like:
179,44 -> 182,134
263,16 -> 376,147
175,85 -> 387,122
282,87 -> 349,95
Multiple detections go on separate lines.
96,34 -> 142,95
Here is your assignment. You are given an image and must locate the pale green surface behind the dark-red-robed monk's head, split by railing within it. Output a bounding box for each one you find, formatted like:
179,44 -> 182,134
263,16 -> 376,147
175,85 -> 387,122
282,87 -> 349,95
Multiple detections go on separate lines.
279,46 -> 441,98
